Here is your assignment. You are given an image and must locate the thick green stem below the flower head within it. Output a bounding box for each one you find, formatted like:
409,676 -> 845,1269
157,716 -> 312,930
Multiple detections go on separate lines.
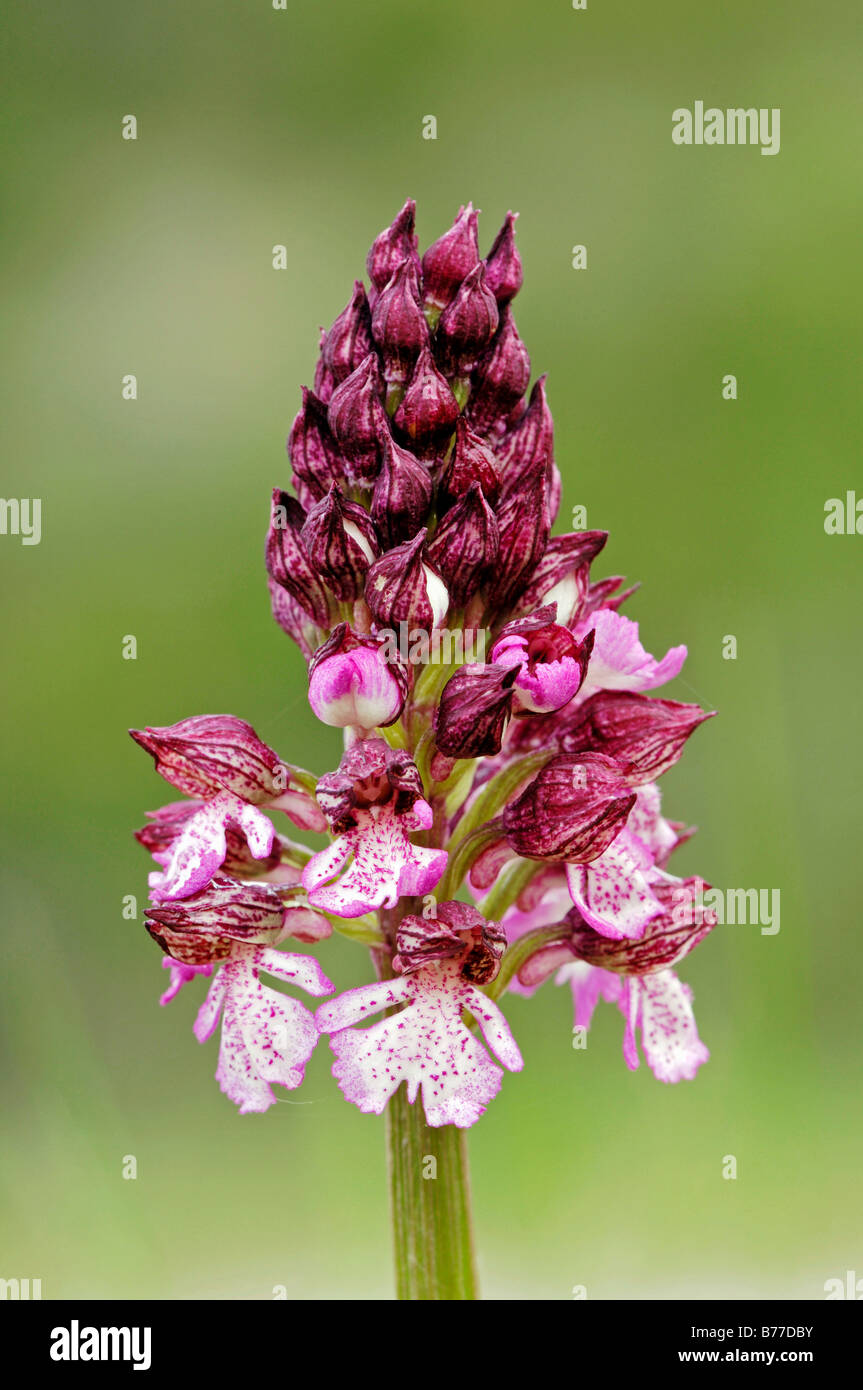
386,1086 -> 478,1301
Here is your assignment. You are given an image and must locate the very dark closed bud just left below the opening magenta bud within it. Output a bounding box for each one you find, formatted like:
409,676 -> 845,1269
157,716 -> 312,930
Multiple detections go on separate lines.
435,664 -> 518,758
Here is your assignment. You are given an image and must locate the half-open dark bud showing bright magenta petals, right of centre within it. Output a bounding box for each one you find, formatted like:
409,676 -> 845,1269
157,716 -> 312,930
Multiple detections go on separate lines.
491,606 -> 593,714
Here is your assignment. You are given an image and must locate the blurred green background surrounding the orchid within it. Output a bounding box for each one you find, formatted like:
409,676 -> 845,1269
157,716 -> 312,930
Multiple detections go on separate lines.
0,0 -> 863,1300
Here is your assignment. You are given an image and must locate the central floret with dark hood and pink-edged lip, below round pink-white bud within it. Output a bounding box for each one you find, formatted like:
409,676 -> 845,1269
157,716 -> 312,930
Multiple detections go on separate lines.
303,738 -> 447,917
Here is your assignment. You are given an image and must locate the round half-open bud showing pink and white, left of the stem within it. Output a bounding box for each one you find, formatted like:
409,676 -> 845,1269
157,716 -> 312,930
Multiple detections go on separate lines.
309,623 -> 407,728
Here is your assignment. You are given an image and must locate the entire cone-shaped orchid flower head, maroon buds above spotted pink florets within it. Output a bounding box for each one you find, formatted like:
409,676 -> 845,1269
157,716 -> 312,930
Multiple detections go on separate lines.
132,202 -> 714,1127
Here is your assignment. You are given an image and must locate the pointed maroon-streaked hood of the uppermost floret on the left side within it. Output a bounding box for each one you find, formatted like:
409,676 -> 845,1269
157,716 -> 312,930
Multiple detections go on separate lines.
129,714 -> 285,805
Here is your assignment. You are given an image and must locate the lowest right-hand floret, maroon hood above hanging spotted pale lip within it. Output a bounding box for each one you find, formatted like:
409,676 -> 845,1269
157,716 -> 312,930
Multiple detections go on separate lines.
518,878 -> 716,1083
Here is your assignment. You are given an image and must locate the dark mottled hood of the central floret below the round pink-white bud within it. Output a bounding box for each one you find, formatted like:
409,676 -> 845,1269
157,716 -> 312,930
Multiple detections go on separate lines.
315,738 -> 431,835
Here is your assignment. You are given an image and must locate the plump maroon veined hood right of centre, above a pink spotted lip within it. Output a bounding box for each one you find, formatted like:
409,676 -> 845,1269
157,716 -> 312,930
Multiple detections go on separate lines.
503,753 -> 635,863
